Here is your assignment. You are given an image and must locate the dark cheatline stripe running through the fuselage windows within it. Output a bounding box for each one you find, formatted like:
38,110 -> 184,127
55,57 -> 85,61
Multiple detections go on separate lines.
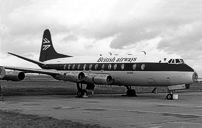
43,62 -> 194,72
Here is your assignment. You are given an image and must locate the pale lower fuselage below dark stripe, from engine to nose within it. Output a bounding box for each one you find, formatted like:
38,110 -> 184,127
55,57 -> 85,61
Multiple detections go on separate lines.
106,71 -> 193,86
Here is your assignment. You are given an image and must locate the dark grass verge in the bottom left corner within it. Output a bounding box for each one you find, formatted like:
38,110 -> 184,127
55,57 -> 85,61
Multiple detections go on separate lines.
0,110 -> 108,128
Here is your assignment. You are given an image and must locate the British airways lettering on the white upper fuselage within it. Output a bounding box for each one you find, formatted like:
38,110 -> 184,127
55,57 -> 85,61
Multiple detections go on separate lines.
97,57 -> 137,62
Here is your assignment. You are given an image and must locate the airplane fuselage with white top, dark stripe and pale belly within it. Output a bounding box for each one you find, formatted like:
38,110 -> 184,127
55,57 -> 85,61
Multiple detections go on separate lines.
39,56 -> 196,86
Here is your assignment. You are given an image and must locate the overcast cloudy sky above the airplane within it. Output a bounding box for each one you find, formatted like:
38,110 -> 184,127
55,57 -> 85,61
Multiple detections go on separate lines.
0,0 -> 202,76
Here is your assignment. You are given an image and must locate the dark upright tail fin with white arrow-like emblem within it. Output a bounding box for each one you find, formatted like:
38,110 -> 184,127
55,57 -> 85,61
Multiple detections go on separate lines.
39,29 -> 71,62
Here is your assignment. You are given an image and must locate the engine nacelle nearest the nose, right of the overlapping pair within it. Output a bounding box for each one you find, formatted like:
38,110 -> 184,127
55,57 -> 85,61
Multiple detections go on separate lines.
81,73 -> 114,85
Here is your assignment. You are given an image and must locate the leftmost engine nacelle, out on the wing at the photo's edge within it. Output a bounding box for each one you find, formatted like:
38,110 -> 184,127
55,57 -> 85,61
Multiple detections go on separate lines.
0,71 -> 25,81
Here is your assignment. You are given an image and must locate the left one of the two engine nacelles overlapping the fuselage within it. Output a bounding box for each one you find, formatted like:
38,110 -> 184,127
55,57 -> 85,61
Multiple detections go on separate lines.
53,72 -> 85,82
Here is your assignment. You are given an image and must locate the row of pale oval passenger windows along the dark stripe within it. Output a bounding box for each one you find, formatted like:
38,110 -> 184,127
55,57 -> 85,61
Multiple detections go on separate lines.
64,64 -> 145,70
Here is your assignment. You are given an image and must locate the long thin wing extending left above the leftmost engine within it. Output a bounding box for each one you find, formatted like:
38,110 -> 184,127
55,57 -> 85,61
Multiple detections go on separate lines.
4,66 -> 59,75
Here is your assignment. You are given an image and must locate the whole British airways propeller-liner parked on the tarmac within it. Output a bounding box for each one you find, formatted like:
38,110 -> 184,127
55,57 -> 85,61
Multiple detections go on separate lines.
0,29 -> 198,100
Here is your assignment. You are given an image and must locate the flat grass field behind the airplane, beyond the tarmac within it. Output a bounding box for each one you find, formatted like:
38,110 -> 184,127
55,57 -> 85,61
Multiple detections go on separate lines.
1,75 -> 202,96
